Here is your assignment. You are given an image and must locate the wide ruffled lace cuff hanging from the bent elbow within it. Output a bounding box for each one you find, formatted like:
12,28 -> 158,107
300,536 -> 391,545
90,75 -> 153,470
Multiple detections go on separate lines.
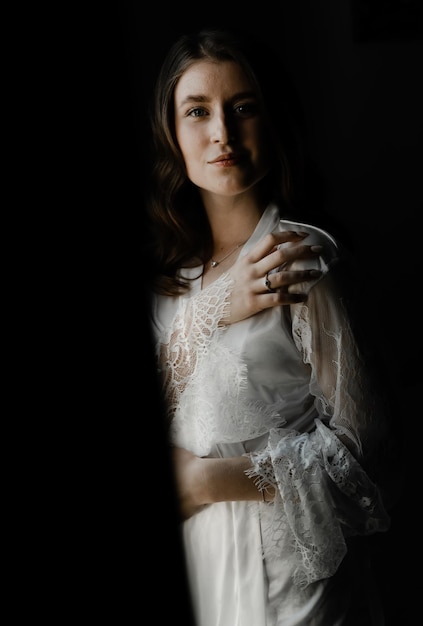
246,420 -> 389,587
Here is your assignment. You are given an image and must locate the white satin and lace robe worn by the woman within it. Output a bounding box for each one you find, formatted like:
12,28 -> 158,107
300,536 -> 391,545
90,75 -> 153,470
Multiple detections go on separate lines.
152,205 -> 389,626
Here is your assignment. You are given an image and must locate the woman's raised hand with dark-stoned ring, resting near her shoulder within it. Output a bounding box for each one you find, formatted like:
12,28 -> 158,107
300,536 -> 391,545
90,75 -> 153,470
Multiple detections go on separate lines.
222,231 -> 322,324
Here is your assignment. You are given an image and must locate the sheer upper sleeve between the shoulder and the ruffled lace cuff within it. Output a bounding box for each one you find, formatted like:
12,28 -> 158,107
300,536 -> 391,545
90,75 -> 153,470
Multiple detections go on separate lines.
292,274 -> 387,464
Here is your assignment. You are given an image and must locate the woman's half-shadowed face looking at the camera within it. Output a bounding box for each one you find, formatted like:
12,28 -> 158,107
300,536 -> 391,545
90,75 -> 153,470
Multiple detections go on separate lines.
174,61 -> 270,196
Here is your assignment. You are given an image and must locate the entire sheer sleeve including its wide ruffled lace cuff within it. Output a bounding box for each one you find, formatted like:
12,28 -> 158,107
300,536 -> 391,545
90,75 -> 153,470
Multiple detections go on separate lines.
249,274 -> 389,586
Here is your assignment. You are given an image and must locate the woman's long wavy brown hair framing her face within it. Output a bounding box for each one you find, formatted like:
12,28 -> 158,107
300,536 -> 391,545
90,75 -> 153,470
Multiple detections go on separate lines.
146,29 -> 299,295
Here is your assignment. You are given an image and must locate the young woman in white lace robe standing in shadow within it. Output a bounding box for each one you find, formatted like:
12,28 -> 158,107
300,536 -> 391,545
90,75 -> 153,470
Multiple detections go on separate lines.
148,25 -> 389,626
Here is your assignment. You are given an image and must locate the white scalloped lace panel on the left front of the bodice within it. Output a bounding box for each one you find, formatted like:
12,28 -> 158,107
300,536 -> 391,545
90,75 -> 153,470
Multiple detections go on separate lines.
158,274 -> 281,456
